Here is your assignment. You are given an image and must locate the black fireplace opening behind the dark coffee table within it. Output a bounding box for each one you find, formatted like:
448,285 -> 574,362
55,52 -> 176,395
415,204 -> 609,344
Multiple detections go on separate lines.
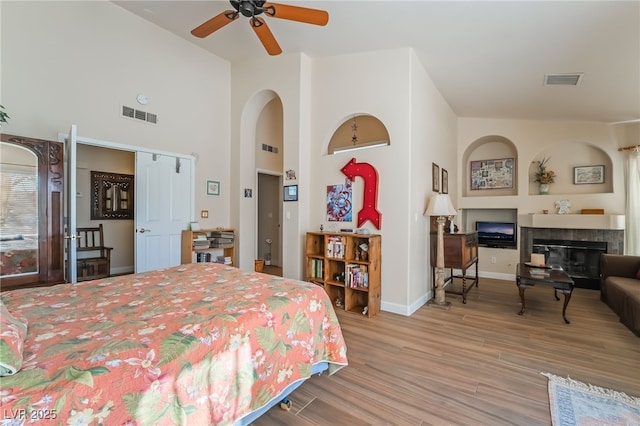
532,238 -> 607,290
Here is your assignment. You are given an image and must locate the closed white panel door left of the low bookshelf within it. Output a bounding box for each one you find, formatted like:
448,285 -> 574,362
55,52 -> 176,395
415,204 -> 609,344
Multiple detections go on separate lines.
135,151 -> 193,272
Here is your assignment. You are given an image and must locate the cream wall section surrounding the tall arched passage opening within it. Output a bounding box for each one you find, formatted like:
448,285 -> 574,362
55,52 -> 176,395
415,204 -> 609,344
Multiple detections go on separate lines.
230,53 -> 310,278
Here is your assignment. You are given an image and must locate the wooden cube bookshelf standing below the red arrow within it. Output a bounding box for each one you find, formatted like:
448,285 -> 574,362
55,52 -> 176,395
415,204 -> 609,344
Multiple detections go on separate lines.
305,232 -> 382,317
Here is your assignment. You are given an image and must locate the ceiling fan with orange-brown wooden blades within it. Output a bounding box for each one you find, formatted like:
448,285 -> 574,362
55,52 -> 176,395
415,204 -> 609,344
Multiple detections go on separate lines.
191,0 -> 329,56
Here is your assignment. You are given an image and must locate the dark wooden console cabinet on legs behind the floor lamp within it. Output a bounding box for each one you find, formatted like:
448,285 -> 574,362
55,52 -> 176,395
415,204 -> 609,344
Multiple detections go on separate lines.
431,231 -> 478,304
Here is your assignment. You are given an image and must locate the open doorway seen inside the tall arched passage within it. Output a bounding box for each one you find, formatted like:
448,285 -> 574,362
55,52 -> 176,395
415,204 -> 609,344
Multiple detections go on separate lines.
256,172 -> 282,276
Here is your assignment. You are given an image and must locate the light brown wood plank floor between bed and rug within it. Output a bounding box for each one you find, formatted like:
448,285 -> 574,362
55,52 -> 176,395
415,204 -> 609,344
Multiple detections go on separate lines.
254,278 -> 640,426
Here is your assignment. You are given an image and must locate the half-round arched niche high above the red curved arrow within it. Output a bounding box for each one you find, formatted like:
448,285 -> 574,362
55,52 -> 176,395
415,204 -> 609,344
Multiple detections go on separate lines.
327,114 -> 391,155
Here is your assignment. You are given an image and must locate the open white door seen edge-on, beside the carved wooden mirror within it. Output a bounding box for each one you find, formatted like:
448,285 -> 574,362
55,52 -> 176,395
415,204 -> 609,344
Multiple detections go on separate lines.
64,124 -> 78,283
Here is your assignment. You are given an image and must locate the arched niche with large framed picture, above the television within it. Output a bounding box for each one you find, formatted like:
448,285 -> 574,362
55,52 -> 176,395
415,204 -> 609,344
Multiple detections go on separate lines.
461,135 -> 518,197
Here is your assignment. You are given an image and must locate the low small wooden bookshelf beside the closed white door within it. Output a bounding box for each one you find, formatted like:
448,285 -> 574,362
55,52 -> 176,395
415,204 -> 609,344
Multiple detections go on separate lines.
180,228 -> 235,265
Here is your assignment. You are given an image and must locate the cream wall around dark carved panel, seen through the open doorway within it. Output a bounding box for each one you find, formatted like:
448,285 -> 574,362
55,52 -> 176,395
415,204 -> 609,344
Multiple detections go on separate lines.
76,145 -> 135,274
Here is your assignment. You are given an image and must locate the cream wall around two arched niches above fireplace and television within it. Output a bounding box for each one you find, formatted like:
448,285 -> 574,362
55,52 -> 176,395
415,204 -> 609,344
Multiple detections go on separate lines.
458,118 -> 629,278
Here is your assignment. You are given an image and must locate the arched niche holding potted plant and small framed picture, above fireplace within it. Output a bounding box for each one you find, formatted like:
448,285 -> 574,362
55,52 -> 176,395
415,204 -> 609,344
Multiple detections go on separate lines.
528,141 -> 613,195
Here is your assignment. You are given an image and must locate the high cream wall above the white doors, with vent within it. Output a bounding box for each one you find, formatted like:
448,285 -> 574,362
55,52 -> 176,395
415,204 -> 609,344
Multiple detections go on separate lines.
0,1 -> 231,227
